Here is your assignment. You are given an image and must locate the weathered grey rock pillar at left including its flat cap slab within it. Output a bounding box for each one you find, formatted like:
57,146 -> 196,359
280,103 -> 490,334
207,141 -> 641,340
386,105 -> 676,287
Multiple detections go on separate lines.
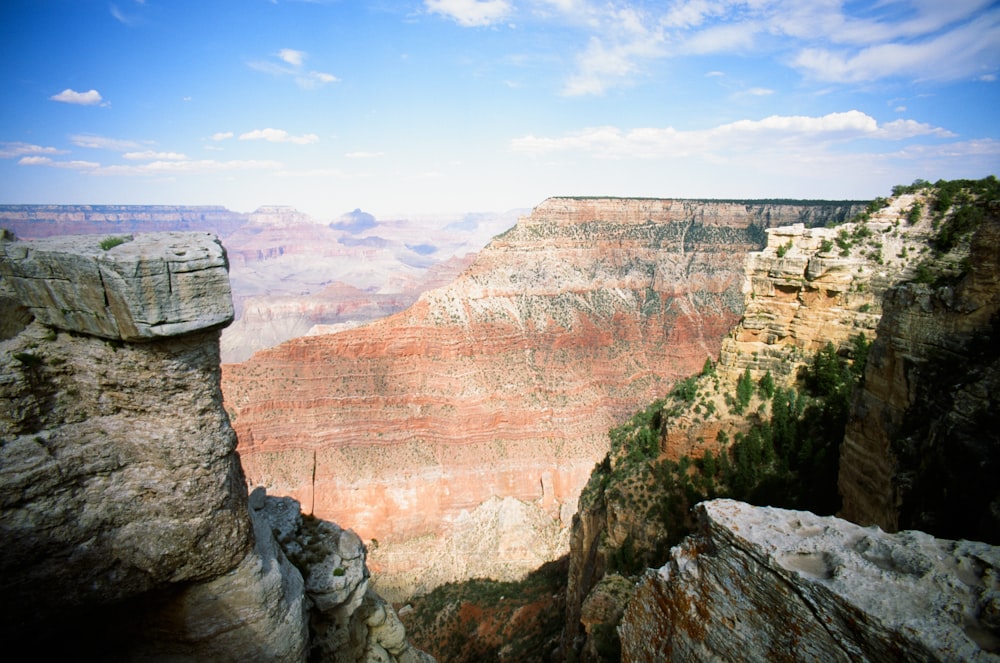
0,233 -> 419,661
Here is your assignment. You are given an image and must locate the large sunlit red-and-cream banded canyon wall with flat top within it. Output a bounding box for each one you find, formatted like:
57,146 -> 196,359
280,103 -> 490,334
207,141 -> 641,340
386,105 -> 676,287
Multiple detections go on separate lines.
223,198 -> 852,594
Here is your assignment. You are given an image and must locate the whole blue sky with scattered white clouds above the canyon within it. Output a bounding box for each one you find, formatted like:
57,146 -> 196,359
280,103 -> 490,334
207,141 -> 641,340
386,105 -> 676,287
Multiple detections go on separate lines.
0,0 -> 1000,219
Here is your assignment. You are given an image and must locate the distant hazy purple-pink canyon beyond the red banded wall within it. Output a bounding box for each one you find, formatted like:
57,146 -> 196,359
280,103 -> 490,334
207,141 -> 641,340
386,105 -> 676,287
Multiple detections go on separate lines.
0,205 -> 515,362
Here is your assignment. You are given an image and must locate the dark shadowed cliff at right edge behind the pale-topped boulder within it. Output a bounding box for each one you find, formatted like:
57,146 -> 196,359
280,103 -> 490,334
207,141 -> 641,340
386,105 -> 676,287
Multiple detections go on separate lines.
839,209 -> 1000,544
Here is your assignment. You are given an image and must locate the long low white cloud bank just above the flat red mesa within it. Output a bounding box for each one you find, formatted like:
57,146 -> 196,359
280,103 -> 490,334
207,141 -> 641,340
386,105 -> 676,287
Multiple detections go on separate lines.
511,110 -> 954,159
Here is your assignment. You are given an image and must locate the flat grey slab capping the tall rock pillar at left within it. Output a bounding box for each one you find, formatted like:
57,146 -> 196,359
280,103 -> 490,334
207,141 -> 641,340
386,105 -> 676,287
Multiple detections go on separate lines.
0,232 -> 233,341
